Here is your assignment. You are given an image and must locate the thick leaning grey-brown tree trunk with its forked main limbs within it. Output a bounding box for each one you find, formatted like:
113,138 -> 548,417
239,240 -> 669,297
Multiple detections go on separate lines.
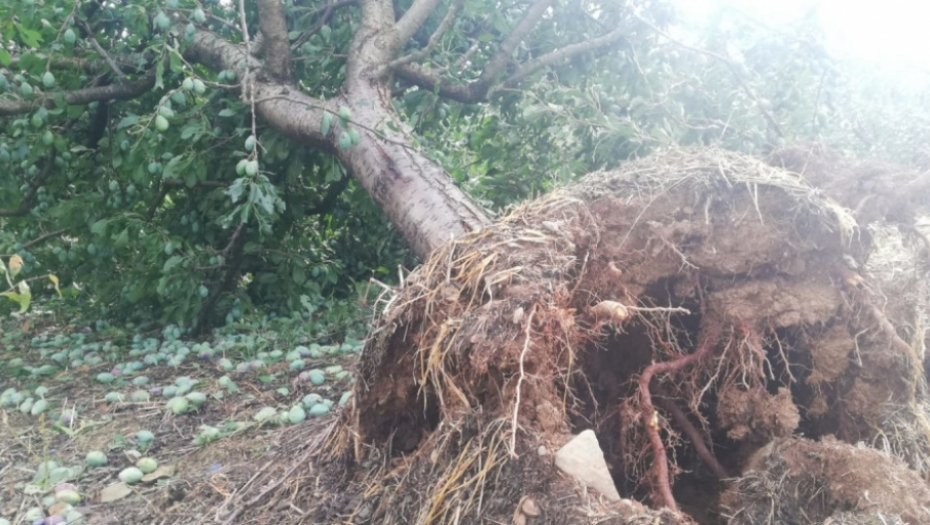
187,21 -> 488,258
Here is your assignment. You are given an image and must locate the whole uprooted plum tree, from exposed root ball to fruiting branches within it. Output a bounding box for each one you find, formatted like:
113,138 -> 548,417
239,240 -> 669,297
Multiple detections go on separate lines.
0,0 -> 930,523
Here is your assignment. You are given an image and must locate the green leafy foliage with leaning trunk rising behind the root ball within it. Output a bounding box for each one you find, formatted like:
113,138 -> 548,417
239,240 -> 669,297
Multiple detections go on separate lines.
0,0 -> 928,326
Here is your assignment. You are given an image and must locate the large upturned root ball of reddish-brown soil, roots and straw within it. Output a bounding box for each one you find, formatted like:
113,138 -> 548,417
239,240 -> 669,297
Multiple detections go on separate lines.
225,150 -> 930,524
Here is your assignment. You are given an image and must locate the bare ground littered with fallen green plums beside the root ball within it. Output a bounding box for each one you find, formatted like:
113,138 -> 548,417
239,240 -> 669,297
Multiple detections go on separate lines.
0,314 -> 360,524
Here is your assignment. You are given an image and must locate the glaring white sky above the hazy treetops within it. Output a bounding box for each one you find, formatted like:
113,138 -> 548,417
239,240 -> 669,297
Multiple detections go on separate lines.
676,0 -> 930,81
